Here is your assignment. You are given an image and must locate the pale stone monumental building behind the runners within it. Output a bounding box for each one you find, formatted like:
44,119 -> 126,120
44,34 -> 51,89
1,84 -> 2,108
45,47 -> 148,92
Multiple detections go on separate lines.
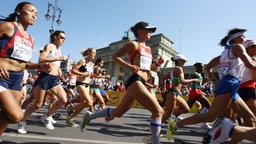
31,34 -> 216,85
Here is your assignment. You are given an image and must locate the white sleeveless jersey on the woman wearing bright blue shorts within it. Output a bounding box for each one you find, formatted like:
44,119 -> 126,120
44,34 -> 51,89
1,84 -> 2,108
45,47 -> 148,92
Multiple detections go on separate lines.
218,46 -> 244,80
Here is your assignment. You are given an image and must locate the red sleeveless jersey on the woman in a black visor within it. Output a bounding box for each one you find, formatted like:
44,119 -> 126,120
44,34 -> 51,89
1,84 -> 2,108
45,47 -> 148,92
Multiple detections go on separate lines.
130,44 -> 152,71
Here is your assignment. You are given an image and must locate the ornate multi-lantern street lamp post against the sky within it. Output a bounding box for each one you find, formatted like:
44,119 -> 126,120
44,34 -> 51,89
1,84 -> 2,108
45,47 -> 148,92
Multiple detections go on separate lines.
45,0 -> 62,34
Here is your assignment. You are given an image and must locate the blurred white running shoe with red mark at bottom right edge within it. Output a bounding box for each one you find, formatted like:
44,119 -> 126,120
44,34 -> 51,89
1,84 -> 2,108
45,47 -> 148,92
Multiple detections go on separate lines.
203,117 -> 234,144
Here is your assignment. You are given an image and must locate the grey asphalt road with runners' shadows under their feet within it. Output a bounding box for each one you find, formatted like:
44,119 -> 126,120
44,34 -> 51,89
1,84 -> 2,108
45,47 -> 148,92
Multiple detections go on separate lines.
1,104 -> 254,144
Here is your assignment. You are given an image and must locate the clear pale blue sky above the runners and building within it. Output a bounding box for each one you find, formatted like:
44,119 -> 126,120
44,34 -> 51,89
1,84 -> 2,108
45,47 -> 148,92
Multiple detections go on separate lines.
0,0 -> 256,65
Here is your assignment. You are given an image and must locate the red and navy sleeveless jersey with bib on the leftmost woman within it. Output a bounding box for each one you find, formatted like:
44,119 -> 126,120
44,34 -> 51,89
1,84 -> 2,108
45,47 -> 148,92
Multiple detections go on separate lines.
0,23 -> 33,62
